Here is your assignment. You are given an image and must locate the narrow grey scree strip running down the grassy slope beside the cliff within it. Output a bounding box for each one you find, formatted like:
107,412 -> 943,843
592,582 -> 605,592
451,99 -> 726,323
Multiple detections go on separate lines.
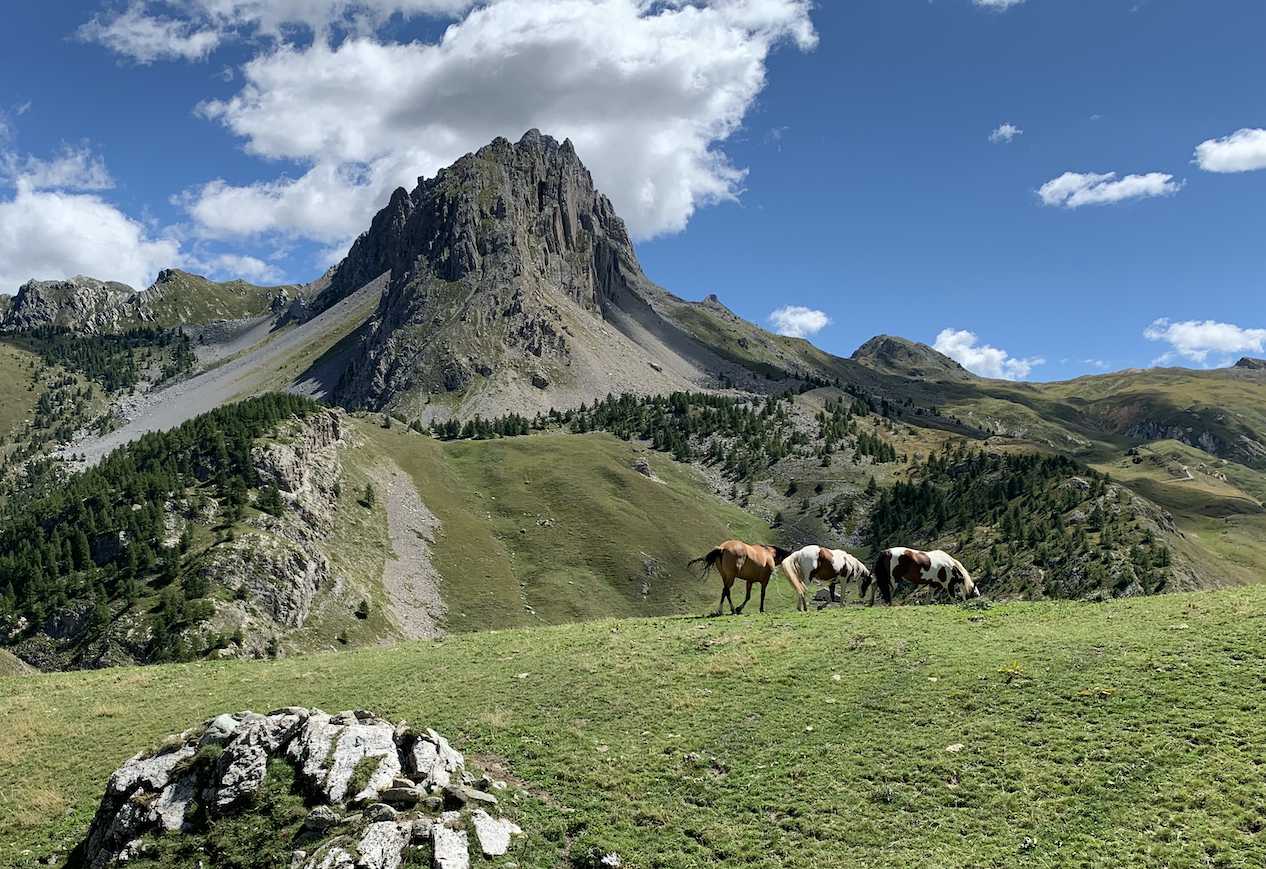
375,467 -> 448,640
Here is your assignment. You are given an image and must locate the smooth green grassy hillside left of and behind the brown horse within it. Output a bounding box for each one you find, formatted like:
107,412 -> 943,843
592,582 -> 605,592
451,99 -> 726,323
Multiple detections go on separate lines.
357,426 -> 774,631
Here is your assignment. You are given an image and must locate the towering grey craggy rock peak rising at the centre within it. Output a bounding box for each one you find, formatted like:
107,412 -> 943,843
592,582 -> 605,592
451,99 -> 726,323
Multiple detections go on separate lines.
321,130 -> 754,415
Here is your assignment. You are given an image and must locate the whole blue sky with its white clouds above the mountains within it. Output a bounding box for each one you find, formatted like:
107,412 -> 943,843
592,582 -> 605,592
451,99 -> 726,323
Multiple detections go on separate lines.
0,0 -> 1266,380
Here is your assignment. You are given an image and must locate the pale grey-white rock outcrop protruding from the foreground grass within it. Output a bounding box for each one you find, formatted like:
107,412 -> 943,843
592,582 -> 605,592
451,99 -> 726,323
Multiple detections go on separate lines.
78,707 -> 523,869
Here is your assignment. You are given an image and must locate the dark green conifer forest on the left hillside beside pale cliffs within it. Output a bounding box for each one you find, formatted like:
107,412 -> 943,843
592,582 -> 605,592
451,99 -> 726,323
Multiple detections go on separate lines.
0,394 -> 320,660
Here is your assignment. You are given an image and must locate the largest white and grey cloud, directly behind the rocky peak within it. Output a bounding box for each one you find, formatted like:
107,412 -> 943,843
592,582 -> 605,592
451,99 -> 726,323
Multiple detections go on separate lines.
96,0 -> 817,244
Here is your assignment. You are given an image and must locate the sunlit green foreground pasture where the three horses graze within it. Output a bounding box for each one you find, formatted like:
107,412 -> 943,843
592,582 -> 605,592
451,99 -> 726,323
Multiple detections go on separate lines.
0,588 -> 1266,868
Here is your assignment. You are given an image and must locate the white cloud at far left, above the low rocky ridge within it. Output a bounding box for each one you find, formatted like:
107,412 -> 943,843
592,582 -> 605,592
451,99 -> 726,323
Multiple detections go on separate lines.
0,146 -> 180,293
